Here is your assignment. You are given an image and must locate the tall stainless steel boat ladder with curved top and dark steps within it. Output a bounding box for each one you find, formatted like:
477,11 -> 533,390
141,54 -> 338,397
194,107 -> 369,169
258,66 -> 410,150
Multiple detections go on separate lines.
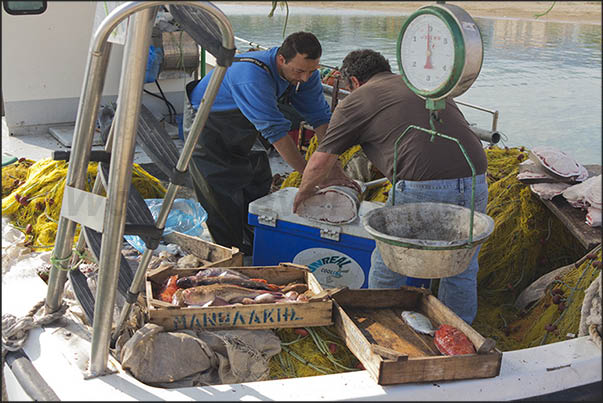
45,1 -> 235,377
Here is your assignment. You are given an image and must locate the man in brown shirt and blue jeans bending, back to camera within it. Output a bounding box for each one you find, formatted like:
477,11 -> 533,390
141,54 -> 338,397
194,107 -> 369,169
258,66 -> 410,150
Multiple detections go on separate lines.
293,49 -> 488,323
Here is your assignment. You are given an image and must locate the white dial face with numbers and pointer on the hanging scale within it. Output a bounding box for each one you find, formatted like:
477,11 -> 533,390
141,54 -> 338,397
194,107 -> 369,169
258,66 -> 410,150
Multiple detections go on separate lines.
402,14 -> 454,91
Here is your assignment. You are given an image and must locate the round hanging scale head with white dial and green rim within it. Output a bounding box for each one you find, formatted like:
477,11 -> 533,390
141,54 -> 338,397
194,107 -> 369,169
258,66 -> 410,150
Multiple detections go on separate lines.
397,4 -> 483,101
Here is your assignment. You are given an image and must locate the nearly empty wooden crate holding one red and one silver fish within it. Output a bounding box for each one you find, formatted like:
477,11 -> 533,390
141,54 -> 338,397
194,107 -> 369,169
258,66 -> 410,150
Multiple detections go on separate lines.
333,286 -> 502,385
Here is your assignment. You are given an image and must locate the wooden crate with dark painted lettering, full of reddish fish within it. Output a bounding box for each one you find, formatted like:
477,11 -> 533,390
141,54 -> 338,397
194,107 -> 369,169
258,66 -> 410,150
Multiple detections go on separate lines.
146,263 -> 333,330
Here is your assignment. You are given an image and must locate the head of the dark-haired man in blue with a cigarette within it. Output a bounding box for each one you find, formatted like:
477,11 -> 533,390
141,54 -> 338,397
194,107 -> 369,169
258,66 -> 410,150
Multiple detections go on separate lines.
276,32 -> 322,85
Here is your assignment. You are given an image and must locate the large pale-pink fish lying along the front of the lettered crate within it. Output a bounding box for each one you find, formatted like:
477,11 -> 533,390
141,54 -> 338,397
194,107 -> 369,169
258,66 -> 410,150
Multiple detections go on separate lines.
172,284 -> 283,306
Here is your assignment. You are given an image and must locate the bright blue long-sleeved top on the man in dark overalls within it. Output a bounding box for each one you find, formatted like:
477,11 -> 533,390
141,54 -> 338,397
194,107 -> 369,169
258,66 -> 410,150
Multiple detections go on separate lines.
191,47 -> 331,144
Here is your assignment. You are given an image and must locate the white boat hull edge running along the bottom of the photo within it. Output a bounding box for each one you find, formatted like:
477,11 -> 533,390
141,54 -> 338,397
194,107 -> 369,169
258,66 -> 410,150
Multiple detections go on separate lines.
2,268 -> 601,401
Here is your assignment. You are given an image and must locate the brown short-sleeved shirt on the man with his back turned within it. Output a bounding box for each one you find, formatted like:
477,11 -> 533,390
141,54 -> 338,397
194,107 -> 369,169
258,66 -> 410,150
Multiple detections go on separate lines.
317,72 -> 488,181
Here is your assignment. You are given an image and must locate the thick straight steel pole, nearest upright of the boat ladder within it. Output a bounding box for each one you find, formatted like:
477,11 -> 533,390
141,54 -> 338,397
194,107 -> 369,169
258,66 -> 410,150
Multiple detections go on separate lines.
90,7 -> 158,376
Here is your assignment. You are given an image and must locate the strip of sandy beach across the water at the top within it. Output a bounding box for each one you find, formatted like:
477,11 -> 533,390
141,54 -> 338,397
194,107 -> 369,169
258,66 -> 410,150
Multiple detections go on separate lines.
243,0 -> 601,25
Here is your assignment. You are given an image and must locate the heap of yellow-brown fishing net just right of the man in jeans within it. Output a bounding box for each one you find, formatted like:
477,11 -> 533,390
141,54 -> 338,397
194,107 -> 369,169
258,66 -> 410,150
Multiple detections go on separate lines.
472,147 -> 587,351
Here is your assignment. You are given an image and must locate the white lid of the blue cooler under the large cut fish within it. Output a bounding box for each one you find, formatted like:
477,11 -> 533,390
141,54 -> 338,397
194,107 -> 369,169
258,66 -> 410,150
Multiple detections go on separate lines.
249,187 -> 384,239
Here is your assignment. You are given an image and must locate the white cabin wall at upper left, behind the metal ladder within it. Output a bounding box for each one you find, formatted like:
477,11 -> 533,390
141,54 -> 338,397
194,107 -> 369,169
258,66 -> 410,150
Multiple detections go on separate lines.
2,1 -> 199,135
